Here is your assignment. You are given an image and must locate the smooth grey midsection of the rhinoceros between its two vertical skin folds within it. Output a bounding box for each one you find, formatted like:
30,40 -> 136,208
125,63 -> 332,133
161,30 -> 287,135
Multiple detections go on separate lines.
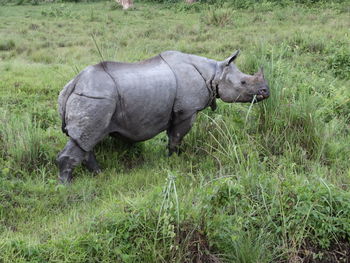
108,59 -> 176,141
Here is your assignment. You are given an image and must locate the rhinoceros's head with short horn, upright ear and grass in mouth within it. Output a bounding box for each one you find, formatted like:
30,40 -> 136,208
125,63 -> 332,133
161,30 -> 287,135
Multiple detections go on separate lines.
216,50 -> 270,102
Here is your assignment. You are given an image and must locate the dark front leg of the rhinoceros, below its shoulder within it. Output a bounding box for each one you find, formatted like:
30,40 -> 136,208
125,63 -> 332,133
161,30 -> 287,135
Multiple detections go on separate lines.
167,114 -> 196,156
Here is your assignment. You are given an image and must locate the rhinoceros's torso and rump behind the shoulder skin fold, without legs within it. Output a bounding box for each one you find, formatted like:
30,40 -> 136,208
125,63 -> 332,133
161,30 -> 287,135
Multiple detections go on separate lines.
59,56 -> 177,151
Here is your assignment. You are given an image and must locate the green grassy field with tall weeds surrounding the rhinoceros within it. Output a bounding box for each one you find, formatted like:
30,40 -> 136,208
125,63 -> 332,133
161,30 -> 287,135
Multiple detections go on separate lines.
0,1 -> 350,263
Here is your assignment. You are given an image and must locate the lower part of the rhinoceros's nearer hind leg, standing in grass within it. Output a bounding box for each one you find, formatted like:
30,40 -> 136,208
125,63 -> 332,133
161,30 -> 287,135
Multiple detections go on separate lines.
56,140 -> 89,184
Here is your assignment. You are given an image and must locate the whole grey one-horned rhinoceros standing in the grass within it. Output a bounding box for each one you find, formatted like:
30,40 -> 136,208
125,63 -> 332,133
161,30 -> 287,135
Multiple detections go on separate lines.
57,51 -> 269,183
